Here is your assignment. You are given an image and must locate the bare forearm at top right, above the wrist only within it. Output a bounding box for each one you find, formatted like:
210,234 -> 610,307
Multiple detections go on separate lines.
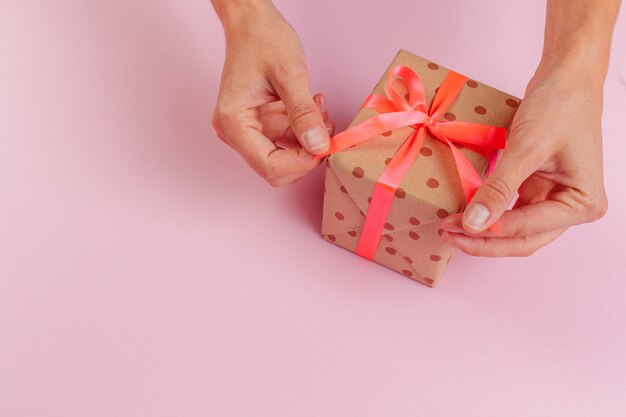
538,0 -> 621,83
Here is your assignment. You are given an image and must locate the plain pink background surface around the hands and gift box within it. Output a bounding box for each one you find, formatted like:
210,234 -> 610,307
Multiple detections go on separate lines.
0,0 -> 626,417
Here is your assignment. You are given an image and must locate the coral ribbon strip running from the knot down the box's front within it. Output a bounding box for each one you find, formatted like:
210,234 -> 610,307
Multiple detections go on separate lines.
356,126 -> 426,260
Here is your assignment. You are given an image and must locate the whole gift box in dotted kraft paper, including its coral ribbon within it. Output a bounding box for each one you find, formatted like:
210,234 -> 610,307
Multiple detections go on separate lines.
322,50 -> 521,287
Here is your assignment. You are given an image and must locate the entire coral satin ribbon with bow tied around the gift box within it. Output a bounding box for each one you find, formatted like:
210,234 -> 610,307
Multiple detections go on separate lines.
317,65 -> 506,259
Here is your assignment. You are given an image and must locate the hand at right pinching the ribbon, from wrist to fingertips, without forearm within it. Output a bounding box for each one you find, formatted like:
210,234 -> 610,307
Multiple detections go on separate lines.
443,60 -> 607,256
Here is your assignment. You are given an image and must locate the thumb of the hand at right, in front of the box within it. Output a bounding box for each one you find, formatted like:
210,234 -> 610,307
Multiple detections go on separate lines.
463,141 -> 539,233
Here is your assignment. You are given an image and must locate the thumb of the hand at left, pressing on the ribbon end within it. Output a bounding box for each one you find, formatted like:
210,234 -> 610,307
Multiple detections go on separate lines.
274,69 -> 330,155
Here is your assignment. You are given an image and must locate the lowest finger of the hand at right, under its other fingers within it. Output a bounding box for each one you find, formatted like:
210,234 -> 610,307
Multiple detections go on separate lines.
441,228 -> 566,257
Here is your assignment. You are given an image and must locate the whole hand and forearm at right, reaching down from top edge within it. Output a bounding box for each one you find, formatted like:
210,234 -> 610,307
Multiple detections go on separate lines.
442,0 -> 621,256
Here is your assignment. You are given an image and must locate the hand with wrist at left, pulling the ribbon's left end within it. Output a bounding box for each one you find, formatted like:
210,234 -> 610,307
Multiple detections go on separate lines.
213,0 -> 334,186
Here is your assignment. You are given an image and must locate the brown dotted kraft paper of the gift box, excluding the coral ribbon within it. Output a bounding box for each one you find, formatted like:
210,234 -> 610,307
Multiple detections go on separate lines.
322,50 -> 520,286
